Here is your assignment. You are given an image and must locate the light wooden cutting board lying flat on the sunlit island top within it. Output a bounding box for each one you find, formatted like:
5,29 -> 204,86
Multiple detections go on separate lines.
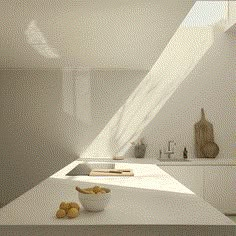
89,169 -> 134,176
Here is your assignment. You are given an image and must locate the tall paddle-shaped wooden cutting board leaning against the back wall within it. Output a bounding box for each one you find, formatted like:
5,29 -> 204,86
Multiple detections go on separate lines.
194,108 -> 214,158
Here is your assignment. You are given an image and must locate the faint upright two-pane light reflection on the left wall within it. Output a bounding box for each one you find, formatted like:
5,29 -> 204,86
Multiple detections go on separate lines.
62,68 -> 92,125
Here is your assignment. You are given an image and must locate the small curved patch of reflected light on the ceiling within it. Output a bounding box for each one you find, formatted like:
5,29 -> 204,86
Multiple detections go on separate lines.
25,20 -> 59,58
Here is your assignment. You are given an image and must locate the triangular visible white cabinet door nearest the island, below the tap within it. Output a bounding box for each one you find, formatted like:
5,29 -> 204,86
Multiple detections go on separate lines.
159,166 -> 204,197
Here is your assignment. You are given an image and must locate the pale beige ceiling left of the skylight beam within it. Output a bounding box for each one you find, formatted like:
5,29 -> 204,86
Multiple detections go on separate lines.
0,0 -> 193,69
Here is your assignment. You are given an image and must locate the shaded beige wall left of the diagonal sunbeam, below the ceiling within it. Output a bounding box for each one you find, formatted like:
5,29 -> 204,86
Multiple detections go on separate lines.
0,69 -> 147,205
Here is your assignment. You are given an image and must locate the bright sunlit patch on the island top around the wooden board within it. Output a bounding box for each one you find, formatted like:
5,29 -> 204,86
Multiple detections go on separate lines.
50,161 -> 194,194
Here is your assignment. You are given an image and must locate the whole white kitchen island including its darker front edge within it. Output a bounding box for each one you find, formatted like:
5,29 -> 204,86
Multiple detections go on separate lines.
0,159 -> 236,236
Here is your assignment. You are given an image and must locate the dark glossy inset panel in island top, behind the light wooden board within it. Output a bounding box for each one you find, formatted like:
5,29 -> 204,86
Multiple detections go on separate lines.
66,162 -> 115,176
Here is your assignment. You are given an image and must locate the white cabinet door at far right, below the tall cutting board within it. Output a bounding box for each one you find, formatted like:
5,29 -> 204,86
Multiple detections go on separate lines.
204,166 -> 236,214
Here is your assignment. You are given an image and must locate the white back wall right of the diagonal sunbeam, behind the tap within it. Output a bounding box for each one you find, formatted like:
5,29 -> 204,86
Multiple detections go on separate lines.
141,29 -> 236,158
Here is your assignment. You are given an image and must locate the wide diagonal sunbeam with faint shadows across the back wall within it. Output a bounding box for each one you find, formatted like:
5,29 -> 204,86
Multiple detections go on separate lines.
80,1 -> 214,158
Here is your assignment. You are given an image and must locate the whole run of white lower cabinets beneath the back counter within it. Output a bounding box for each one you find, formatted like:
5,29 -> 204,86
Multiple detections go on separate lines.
159,166 -> 236,214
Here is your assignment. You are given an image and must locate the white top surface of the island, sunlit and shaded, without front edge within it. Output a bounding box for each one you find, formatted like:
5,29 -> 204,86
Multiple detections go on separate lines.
0,159 -> 234,226
